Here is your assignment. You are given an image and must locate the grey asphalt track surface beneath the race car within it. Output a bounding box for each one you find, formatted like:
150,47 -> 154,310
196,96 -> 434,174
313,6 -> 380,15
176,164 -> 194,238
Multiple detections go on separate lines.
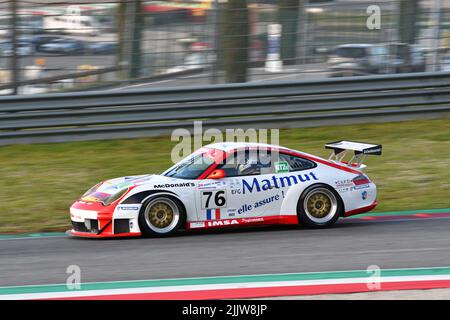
0,218 -> 450,286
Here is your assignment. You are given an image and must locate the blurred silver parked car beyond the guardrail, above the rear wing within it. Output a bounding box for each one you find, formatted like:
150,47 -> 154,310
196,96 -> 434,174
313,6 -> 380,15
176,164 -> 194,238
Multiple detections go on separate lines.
328,44 -> 389,77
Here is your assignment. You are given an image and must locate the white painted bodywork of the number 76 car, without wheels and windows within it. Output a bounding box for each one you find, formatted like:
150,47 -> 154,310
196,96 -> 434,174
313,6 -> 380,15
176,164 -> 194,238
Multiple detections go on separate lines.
71,143 -> 376,233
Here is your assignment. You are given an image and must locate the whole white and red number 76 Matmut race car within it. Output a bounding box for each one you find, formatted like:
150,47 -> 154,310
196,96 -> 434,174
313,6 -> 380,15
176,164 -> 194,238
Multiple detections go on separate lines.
69,141 -> 381,237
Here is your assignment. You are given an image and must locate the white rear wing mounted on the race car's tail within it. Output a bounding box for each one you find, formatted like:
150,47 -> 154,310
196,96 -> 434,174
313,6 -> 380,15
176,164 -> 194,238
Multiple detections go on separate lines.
325,140 -> 382,170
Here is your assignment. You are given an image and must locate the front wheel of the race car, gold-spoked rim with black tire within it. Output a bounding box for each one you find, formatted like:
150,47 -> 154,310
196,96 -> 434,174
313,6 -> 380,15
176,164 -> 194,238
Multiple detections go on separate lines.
139,195 -> 186,237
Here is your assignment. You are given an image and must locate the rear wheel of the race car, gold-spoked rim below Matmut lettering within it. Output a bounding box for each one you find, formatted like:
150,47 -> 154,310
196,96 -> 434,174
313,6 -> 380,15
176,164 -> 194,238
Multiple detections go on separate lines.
297,184 -> 344,228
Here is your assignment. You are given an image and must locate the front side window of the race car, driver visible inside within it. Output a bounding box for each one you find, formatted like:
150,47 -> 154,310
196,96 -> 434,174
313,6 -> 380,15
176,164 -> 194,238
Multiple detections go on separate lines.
220,150 -> 275,177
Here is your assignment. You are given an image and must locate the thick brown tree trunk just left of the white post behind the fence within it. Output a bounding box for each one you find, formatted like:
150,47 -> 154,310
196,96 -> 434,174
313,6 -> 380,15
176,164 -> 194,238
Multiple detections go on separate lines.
221,0 -> 249,82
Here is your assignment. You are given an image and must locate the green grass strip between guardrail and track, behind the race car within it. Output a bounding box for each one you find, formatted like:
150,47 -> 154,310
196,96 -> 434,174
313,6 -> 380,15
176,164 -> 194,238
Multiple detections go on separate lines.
0,119 -> 450,233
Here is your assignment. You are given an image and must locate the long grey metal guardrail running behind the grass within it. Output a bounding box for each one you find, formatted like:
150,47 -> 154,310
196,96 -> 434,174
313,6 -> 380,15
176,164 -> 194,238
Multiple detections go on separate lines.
0,72 -> 450,144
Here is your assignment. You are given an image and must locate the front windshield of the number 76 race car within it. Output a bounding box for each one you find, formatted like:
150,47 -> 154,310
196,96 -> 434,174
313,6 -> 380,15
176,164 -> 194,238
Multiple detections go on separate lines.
163,151 -> 219,179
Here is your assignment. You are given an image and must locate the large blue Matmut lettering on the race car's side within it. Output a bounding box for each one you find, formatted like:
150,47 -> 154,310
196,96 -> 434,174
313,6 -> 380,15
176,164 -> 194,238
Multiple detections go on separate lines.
242,172 -> 319,194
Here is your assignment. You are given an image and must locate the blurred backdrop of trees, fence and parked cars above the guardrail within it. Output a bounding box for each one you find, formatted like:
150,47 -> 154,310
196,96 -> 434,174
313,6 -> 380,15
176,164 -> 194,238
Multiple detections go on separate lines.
0,0 -> 450,95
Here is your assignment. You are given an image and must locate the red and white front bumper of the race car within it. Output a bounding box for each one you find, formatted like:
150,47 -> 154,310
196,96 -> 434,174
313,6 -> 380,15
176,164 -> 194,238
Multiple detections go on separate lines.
67,201 -> 141,238
